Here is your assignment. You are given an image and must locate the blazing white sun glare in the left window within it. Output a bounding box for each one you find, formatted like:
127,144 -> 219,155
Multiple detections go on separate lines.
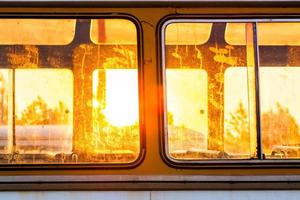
93,69 -> 139,127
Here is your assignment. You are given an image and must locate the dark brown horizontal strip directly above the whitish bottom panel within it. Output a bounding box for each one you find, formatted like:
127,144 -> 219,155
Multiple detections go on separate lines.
0,182 -> 300,191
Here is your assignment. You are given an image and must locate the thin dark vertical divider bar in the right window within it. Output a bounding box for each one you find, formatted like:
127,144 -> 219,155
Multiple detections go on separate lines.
253,22 -> 264,160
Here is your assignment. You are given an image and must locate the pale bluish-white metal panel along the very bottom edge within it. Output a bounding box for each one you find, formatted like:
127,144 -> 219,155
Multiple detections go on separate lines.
0,190 -> 300,200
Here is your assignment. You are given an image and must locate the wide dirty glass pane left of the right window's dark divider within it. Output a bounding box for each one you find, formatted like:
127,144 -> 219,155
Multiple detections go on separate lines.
164,22 -> 256,160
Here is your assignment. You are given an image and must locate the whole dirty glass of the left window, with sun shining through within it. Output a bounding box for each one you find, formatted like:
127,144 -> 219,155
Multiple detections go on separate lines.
0,18 -> 140,164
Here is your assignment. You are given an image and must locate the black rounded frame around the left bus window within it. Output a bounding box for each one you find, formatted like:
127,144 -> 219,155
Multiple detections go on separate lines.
0,13 -> 146,171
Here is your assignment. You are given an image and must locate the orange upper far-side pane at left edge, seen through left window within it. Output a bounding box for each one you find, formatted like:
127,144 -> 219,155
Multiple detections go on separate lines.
0,19 -> 75,45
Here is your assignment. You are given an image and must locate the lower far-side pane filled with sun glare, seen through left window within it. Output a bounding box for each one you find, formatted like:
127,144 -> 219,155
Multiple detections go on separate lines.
93,69 -> 140,162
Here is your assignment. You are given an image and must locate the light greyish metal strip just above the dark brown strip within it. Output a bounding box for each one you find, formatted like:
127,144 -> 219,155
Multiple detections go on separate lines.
0,175 -> 300,184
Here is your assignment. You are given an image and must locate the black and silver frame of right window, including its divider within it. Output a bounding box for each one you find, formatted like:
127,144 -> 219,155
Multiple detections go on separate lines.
157,15 -> 300,169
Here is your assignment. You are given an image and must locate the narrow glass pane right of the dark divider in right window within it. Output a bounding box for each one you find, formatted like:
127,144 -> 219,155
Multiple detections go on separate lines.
258,22 -> 300,159
